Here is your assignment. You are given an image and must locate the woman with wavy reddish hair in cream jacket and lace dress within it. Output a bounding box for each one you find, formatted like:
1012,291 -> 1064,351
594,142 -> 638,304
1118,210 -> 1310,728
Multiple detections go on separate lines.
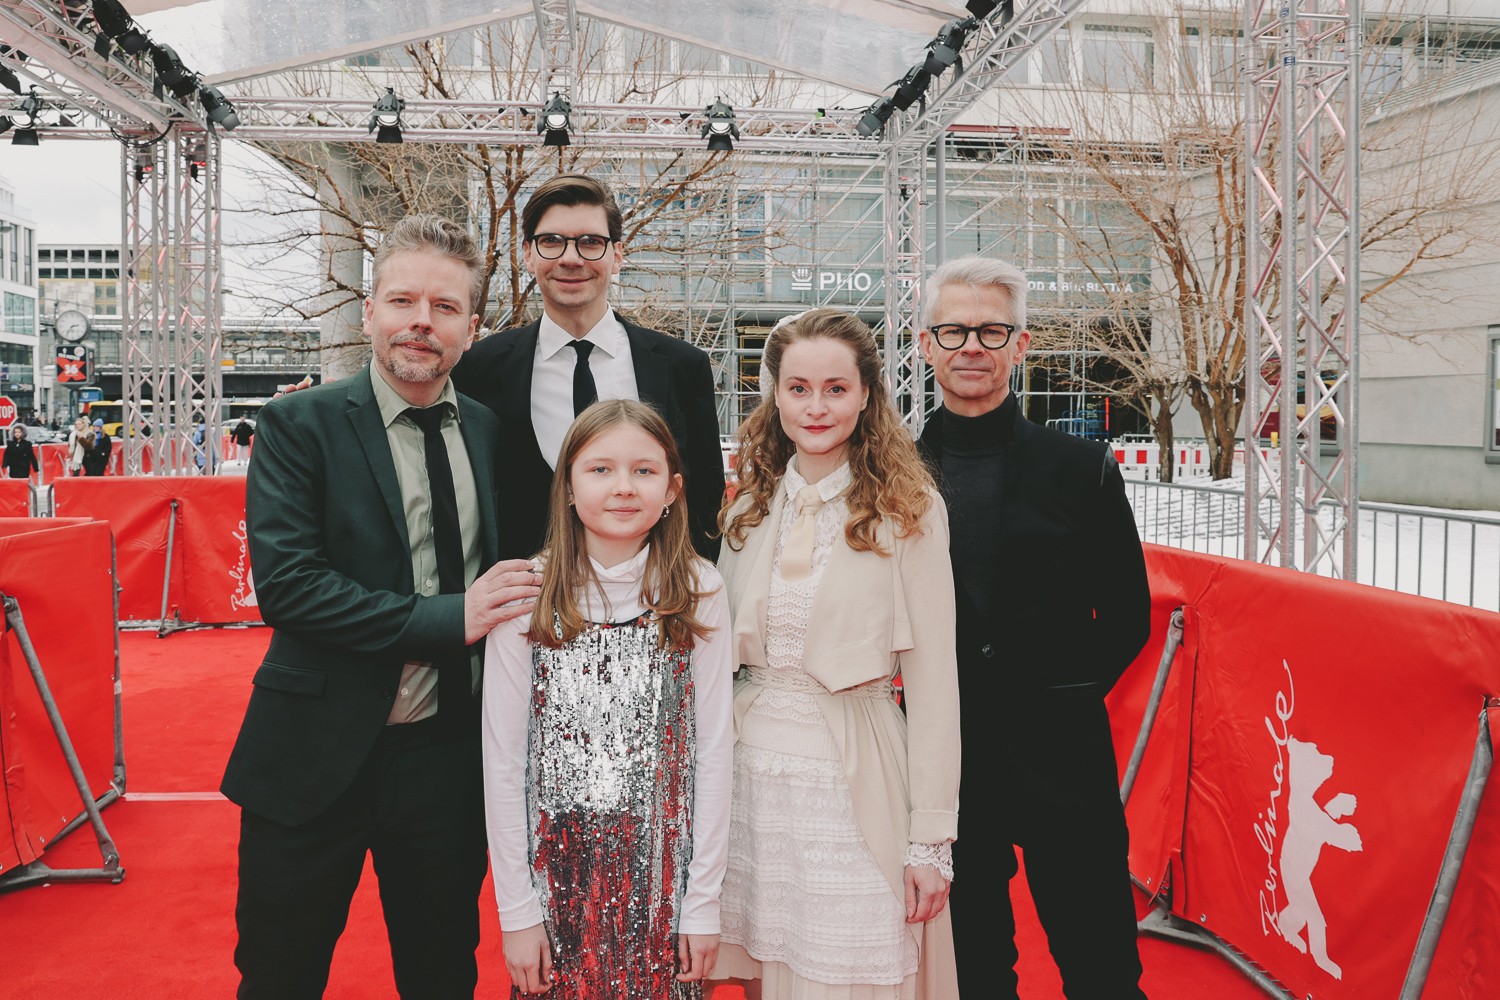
719,309 -> 959,1000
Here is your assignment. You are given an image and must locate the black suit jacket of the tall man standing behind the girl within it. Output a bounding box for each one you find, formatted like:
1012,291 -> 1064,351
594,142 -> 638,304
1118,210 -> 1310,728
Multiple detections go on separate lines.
447,313 -> 725,561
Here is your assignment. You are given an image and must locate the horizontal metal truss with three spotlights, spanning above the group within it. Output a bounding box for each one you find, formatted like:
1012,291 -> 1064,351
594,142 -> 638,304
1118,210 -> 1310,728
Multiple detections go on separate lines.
222,97 -> 885,156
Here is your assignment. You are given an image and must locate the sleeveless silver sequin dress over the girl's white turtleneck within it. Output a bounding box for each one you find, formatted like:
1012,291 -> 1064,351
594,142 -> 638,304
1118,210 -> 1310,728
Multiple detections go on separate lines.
525,616 -> 702,1000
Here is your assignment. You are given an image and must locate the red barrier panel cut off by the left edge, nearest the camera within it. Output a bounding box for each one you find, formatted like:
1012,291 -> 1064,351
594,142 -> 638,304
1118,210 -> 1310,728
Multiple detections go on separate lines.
0,519 -> 114,871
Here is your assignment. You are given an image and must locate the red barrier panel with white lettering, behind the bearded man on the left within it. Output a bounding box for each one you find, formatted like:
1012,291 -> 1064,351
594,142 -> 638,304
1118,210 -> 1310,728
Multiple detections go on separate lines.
53,475 -> 260,622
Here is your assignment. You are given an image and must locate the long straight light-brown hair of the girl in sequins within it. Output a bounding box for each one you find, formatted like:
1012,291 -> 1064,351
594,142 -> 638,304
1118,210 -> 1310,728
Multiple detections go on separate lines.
527,399 -> 713,649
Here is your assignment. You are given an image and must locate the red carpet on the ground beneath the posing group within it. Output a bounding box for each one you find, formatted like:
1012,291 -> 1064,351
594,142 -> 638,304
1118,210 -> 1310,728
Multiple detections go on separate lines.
0,628 -> 1265,1000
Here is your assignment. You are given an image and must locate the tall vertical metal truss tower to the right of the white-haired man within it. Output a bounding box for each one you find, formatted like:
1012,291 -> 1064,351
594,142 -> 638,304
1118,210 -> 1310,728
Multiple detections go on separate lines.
1245,0 -> 1362,580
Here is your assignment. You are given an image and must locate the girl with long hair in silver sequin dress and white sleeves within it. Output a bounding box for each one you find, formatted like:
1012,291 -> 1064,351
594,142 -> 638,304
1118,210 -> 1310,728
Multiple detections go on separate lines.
483,399 -> 734,1000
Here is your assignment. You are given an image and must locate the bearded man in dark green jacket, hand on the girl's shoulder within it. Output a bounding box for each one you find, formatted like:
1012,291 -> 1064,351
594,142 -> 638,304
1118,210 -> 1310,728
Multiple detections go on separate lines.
222,216 -> 537,1000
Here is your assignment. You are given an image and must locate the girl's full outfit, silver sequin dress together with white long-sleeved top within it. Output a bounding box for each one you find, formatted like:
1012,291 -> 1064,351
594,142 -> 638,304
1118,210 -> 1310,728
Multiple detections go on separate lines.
483,553 -> 734,1000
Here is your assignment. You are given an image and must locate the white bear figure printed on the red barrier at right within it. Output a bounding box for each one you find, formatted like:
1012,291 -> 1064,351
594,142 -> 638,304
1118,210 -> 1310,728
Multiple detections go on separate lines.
1277,736 -> 1364,979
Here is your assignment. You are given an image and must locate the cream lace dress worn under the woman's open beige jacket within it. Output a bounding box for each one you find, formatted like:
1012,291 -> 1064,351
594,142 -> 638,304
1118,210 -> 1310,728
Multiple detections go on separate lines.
717,460 -> 918,1000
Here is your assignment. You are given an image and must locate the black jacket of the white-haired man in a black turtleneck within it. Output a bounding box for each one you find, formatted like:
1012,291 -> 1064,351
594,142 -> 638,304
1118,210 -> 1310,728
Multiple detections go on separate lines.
918,406 -> 1151,696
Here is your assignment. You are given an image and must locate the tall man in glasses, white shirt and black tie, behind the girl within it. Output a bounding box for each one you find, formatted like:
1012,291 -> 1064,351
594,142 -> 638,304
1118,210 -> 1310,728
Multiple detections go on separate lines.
453,174 -> 725,559
